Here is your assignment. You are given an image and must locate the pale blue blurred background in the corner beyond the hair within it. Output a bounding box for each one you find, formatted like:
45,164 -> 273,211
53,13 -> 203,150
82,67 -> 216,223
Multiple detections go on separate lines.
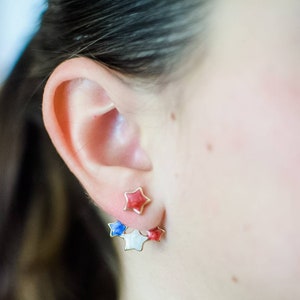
0,0 -> 47,87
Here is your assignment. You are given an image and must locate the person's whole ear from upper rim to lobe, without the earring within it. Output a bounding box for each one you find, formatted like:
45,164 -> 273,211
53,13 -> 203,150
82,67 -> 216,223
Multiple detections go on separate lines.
43,58 -> 164,230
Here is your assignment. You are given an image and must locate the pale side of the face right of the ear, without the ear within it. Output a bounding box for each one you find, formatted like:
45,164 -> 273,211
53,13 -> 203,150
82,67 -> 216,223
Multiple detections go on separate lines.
150,1 -> 300,300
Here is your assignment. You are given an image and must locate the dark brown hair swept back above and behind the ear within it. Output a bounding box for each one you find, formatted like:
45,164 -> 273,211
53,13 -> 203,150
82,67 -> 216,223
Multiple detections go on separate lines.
0,0 -> 204,300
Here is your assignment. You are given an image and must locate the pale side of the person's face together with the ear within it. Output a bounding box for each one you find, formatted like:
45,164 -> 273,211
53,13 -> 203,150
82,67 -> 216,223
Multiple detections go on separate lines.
43,0 -> 300,300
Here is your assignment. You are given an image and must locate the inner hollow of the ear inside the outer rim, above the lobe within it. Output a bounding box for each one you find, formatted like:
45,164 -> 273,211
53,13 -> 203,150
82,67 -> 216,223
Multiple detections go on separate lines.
49,79 -> 151,172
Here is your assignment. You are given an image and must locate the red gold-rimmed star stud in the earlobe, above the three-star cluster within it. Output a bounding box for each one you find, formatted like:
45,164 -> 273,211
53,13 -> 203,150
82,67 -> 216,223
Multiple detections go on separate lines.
124,187 -> 151,215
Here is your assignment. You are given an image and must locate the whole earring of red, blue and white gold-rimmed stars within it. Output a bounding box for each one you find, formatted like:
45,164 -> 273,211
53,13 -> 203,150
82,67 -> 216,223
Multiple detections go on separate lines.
108,187 -> 165,251
